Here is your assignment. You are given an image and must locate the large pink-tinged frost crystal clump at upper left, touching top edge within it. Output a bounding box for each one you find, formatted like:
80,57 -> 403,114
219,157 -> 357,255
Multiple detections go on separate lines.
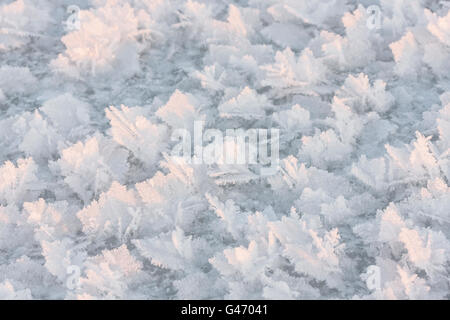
52,1 -> 145,77
